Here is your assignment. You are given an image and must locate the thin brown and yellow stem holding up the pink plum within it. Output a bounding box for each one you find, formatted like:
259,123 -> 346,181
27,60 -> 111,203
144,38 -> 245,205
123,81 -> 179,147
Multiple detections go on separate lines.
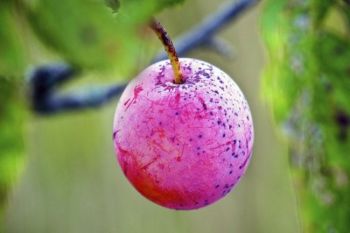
149,19 -> 183,84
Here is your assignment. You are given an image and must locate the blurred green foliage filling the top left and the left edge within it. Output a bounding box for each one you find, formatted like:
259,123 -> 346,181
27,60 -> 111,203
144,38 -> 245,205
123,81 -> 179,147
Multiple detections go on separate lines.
0,0 -> 183,225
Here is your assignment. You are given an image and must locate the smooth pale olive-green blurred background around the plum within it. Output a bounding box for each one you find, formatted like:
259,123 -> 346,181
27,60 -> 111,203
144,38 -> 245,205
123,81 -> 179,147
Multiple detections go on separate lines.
5,0 -> 300,233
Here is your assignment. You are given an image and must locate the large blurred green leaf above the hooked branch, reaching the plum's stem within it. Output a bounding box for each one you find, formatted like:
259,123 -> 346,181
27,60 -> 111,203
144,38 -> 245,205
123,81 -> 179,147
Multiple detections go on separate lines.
27,0 -> 186,77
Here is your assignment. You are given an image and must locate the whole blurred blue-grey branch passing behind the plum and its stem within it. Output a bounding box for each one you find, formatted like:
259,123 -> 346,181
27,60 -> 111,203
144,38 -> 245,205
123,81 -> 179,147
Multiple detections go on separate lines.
28,0 -> 259,114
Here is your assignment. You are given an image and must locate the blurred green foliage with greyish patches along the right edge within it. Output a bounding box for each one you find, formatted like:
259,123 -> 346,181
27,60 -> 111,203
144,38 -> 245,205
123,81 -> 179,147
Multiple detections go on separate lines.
262,0 -> 350,233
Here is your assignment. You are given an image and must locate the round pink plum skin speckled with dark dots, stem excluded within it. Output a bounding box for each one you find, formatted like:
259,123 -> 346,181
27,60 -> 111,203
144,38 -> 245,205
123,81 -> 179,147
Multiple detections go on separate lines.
113,58 -> 254,210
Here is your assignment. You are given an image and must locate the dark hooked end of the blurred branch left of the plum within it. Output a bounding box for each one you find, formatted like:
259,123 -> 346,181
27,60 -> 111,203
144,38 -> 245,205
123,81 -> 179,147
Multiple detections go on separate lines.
29,64 -> 127,114
